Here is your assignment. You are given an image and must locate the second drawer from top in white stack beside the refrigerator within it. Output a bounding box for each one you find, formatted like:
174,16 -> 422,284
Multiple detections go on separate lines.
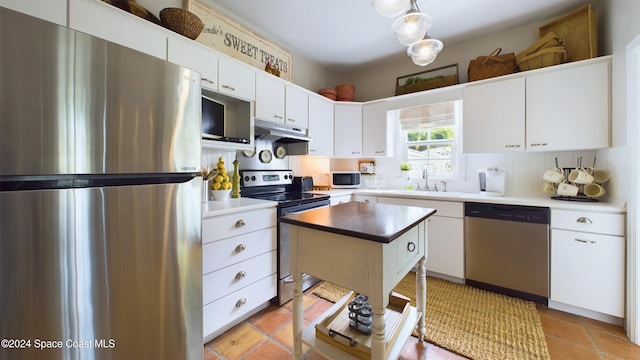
202,227 -> 278,274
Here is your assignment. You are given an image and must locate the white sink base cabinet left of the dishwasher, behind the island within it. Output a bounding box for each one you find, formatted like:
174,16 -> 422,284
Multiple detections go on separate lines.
378,196 -> 464,279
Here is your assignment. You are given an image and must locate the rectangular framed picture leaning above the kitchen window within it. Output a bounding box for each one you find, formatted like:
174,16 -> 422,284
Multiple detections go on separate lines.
396,64 -> 459,95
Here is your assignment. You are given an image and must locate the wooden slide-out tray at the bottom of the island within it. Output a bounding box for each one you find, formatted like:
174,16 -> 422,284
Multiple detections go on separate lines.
315,292 -> 411,360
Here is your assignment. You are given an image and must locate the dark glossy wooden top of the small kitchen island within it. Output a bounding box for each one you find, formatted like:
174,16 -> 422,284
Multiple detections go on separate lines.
279,202 -> 436,243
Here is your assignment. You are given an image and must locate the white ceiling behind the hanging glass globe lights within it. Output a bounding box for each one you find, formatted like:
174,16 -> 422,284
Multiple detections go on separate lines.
204,0 -> 588,75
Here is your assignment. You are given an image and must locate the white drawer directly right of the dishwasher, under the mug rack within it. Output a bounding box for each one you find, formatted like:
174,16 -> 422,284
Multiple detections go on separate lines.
551,210 -> 624,236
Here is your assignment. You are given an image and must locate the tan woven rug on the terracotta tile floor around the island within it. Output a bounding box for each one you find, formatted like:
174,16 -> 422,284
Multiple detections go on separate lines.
313,272 -> 550,360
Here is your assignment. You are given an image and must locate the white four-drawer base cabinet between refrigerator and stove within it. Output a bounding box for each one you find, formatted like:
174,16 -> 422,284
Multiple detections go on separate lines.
202,207 -> 278,341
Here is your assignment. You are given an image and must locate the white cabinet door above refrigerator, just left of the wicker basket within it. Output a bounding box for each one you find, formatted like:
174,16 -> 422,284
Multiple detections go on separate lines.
69,0 -> 168,60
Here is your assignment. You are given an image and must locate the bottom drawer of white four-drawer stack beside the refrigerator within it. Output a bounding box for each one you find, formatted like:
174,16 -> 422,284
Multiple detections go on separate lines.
202,274 -> 277,338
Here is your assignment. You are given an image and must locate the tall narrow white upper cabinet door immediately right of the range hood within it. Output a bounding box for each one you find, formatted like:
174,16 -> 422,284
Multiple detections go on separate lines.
308,96 -> 333,156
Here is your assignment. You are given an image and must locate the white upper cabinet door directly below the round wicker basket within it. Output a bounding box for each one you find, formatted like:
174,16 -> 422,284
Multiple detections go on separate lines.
167,35 -> 220,91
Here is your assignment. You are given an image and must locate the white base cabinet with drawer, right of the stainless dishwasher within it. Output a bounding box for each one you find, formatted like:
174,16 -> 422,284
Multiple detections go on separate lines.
550,210 -> 625,318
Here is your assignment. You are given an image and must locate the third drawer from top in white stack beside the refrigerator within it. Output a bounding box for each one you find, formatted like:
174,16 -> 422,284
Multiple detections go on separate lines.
202,250 -> 278,305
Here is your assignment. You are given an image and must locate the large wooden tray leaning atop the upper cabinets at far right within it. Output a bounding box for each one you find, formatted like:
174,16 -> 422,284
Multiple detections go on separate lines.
538,5 -> 598,62
